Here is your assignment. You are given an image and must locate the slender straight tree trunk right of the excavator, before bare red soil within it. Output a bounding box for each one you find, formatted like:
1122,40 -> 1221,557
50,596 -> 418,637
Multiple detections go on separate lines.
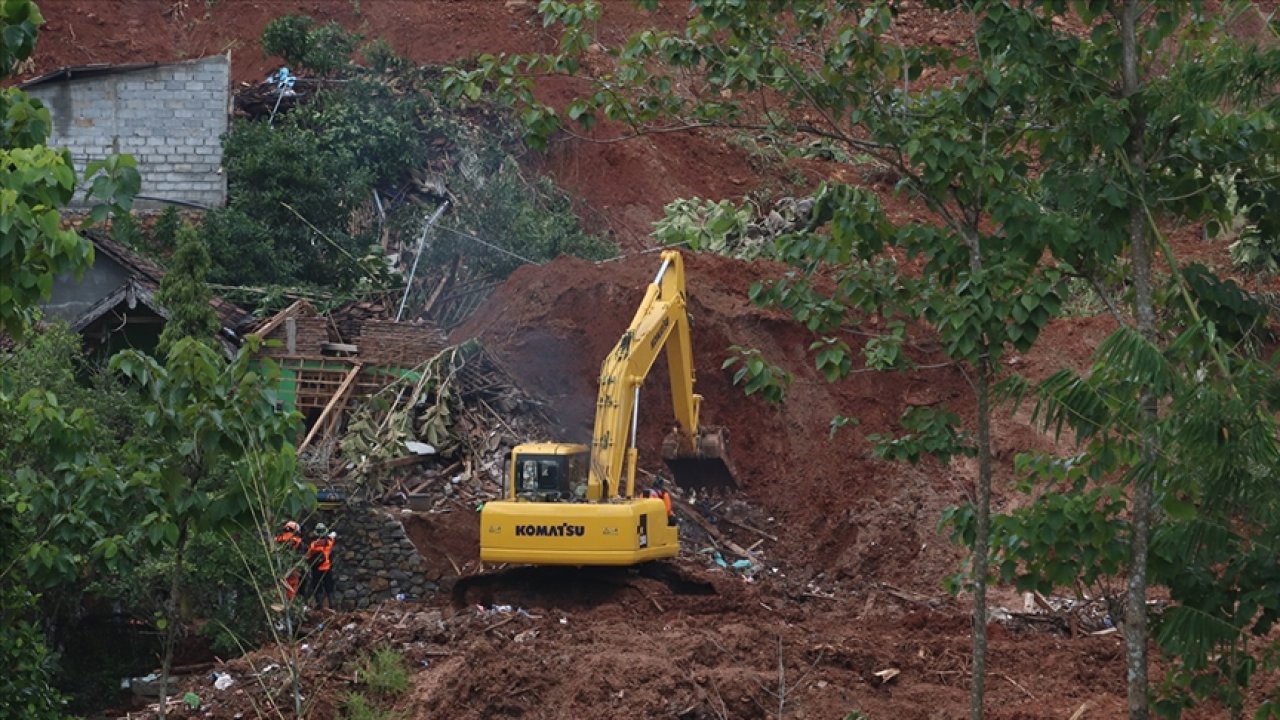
969,350 -> 991,720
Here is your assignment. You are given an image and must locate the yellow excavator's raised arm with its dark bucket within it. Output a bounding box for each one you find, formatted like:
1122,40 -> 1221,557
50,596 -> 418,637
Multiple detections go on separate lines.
586,251 -> 732,500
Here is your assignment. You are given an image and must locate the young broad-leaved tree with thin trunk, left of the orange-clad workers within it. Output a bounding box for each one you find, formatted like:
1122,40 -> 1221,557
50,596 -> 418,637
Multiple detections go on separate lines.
110,338 -> 310,715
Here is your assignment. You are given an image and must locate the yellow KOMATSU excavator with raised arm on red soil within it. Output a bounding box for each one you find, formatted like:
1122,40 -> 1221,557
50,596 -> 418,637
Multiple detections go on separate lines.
480,251 -> 737,565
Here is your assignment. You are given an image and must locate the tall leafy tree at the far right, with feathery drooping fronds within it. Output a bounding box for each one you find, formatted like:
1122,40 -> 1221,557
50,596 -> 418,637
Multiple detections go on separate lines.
977,1 -> 1280,717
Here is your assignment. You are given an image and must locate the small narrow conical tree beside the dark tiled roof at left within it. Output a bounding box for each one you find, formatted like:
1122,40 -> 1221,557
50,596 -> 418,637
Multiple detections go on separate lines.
156,225 -> 219,356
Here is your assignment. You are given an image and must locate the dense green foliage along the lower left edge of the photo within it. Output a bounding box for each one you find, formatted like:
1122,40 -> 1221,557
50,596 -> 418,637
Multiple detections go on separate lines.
0,324 -> 151,717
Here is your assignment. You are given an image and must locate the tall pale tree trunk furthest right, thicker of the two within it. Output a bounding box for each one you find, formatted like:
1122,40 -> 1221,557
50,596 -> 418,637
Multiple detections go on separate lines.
1120,0 -> 1158,720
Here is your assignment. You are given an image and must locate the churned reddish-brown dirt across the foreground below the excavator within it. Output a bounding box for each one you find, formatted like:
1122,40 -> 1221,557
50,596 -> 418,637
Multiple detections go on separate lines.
154,535 -> 1124,720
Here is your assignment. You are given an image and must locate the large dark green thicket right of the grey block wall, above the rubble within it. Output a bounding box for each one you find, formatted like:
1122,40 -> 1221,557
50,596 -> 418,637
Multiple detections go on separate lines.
208,37 -> 613,297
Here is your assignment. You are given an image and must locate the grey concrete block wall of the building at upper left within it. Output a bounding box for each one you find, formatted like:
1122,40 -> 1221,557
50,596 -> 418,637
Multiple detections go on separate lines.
26,55 -> 230,208
